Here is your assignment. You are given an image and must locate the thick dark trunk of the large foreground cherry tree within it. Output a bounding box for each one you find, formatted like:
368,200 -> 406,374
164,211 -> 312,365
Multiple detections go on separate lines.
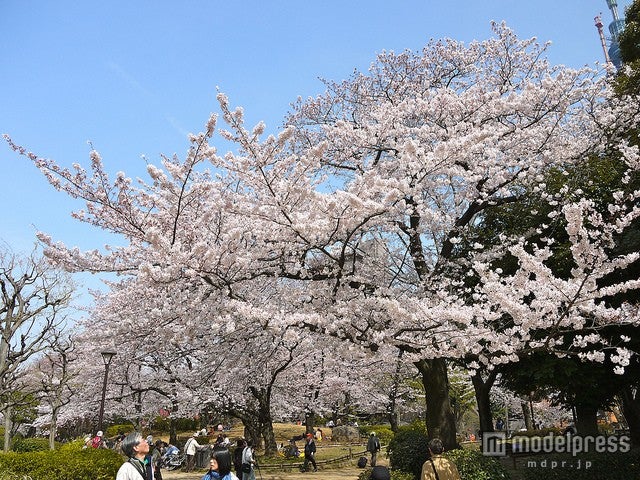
415,358 -> 457,450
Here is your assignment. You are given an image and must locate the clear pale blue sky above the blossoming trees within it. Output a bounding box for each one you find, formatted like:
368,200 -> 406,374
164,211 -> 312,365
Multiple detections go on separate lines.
0,0 -> 631,304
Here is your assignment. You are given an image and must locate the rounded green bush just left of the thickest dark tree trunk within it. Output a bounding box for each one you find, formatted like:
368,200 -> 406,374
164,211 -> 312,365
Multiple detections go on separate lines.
389,422 -> 429,478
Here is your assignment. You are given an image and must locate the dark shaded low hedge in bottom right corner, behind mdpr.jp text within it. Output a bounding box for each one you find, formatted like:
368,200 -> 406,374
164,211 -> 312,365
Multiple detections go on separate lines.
522,450 -> 640,480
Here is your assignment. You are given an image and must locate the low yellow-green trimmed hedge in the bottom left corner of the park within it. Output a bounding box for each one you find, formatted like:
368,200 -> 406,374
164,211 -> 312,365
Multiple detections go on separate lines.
0,448 -> 123,480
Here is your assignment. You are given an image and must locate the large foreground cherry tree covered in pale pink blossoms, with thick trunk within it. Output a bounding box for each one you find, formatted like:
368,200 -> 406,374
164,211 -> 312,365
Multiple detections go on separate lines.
9,25 -> 638,447
